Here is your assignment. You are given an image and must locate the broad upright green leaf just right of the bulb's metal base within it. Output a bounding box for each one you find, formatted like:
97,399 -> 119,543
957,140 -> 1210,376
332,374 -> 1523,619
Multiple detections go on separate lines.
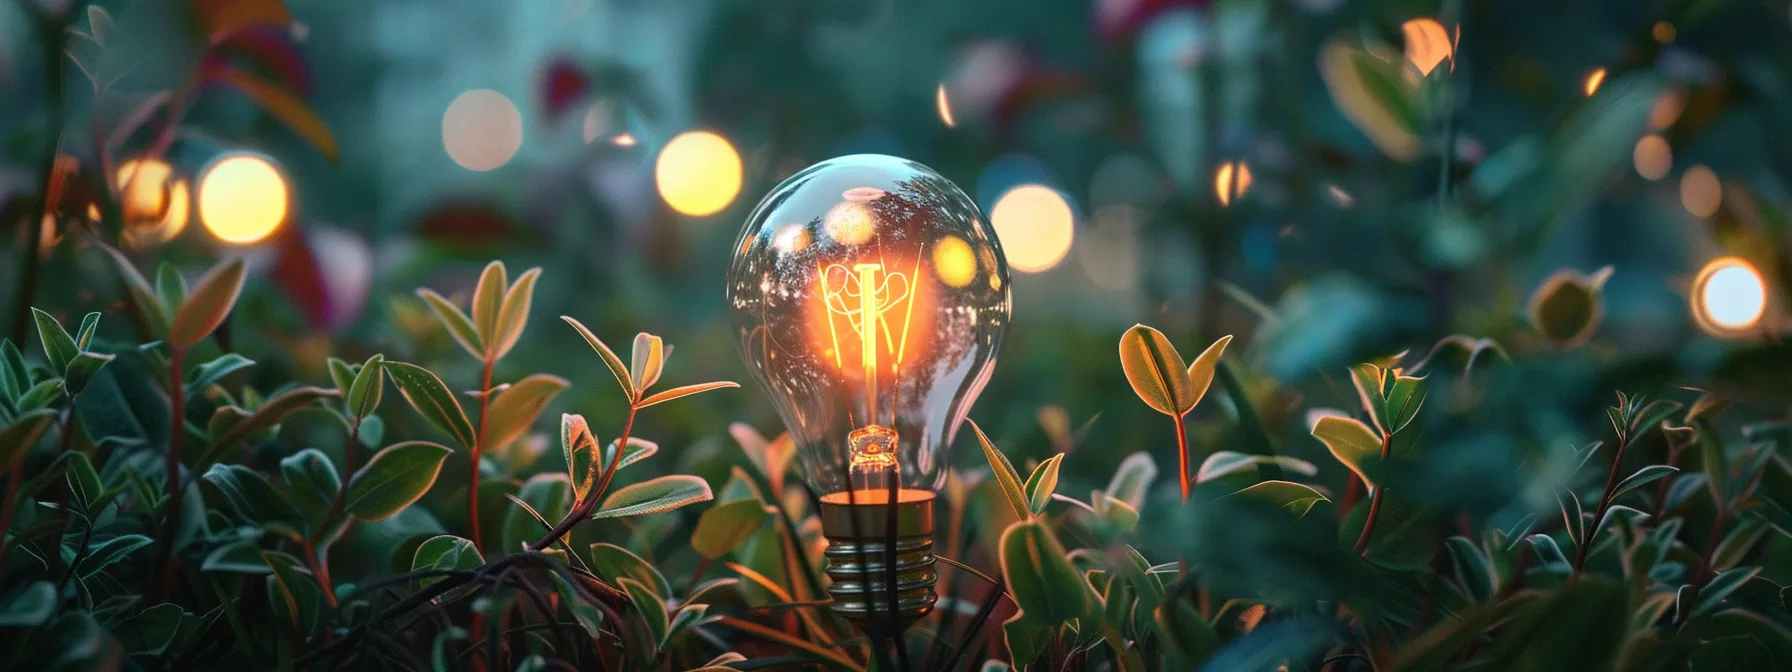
1002,520 -> 1095,625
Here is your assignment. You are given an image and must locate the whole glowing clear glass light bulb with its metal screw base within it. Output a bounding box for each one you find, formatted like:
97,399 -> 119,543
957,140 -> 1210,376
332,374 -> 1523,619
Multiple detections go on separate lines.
728,154 -> 1012,627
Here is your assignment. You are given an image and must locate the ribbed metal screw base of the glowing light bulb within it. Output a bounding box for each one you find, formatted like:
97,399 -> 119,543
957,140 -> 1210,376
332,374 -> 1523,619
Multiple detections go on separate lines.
821,489 -> 939,634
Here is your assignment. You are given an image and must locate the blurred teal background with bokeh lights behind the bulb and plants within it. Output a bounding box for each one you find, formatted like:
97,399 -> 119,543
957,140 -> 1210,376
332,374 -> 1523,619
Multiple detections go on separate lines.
0,0 -> 1792,559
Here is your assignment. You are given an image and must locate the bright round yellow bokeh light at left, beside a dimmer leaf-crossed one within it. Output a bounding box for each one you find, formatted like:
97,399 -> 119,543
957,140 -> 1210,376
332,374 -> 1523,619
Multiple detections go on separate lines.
199,154 -> 290,246
